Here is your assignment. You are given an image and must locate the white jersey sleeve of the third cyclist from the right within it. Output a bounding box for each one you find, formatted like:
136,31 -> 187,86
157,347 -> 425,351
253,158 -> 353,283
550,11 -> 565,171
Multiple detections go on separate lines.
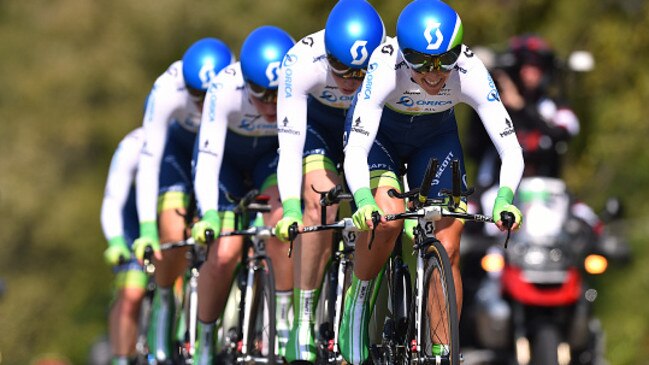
194,72 -> 241,214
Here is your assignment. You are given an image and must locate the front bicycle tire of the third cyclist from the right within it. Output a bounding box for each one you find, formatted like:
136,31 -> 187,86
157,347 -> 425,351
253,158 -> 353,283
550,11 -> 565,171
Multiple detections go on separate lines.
247,258 -> 276,365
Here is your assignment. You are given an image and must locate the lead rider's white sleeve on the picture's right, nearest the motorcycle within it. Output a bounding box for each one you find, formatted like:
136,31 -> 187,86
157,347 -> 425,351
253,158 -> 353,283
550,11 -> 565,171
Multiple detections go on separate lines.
461,50 -> 525,191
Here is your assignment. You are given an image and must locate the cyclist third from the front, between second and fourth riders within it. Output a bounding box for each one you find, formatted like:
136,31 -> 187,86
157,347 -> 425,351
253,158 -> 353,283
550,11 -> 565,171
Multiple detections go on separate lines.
192,26 -> 295,364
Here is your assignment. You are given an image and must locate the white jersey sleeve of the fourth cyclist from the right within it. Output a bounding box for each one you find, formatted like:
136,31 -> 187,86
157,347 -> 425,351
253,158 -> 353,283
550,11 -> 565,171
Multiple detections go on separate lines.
136,66 -> 179,222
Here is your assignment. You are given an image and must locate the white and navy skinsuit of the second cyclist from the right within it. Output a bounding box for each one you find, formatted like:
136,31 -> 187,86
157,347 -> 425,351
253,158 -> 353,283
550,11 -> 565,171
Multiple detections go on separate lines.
277,30 -> 354,200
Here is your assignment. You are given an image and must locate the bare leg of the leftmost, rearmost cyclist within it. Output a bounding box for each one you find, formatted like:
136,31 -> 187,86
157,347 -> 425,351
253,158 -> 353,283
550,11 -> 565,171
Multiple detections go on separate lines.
109,261 -> 147,361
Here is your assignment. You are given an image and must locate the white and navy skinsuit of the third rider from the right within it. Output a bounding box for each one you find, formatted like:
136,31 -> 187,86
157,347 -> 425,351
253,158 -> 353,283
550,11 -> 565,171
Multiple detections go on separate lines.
194,62 -> 278,213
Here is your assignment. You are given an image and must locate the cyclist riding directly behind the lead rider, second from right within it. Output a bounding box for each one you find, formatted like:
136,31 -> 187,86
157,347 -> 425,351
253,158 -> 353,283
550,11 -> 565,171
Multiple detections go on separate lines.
276,0 -> 385,362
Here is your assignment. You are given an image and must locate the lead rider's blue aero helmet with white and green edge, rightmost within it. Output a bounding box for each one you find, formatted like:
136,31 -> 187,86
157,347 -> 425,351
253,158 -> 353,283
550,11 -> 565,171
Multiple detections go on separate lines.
397,0 -> 464,72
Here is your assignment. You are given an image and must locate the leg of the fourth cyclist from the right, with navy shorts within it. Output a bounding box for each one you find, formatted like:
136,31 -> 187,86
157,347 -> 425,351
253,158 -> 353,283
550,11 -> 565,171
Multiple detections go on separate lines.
149,128 -> 196,361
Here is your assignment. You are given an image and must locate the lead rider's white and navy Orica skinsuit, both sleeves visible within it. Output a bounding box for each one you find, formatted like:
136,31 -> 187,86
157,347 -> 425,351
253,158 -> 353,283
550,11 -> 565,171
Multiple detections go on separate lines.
345,38 -> 524,199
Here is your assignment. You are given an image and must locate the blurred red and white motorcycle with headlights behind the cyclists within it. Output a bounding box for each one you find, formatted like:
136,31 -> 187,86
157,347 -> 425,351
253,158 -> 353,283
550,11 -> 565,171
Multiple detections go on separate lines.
473,177 -> 608,365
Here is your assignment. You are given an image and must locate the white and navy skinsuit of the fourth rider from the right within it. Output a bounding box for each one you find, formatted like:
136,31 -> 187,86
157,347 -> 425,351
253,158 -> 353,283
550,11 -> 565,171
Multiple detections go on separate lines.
136,61 -> 202,222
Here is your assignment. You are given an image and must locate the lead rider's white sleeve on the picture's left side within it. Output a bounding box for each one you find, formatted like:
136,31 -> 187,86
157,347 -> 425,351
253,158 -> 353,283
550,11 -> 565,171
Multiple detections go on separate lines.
344,39 -> 398,193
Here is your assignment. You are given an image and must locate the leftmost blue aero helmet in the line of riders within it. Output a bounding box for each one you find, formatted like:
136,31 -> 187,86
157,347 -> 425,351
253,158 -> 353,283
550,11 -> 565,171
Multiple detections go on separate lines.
183,38 -> 234,94
